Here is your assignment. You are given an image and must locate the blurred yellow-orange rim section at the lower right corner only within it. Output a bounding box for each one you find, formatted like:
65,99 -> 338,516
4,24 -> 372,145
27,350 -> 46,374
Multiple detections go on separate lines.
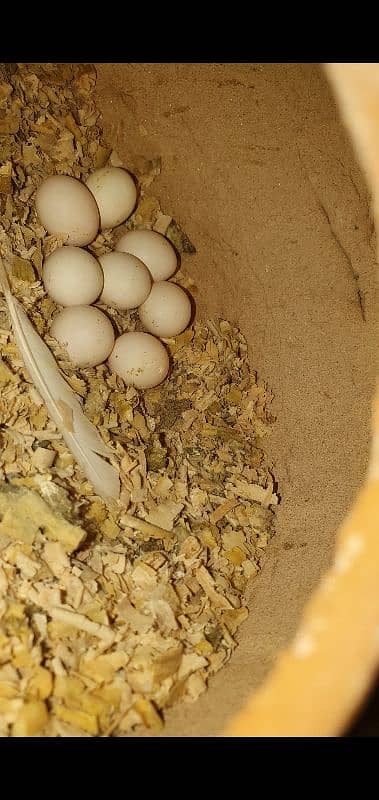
224,468 -> 379,736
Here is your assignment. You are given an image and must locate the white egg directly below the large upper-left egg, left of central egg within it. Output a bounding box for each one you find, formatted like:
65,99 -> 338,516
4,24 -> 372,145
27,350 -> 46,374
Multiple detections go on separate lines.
42,245 -> 104,306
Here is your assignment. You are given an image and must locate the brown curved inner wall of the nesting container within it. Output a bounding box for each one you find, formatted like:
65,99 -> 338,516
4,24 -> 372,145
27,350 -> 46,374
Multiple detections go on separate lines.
96,64 -> 376,735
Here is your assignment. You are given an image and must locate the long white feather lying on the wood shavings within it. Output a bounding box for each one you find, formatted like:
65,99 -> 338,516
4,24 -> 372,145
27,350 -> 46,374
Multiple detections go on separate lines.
0,259 -> 120,498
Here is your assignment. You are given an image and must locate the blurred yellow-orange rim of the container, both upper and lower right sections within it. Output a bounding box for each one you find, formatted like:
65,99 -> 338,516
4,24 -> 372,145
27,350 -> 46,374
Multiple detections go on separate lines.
224,63 -> 379,736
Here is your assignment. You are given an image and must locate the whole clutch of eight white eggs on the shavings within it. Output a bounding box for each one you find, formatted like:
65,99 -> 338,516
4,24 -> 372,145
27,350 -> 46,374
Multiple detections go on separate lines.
35,167 -> 191,389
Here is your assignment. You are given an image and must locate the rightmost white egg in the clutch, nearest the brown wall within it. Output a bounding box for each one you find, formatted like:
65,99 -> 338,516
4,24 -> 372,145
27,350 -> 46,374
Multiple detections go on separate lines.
138,281 -> 192,338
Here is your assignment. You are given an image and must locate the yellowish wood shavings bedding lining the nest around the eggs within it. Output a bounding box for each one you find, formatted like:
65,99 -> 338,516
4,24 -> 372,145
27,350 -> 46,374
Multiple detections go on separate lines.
0,64 -> 278,736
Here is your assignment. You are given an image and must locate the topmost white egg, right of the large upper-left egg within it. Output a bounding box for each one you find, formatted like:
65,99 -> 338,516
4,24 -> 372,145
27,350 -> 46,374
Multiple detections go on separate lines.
86,167 -> 137,230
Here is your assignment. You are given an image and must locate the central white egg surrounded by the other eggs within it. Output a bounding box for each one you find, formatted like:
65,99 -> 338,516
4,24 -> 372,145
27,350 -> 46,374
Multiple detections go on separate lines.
99,253 -> 151,311
